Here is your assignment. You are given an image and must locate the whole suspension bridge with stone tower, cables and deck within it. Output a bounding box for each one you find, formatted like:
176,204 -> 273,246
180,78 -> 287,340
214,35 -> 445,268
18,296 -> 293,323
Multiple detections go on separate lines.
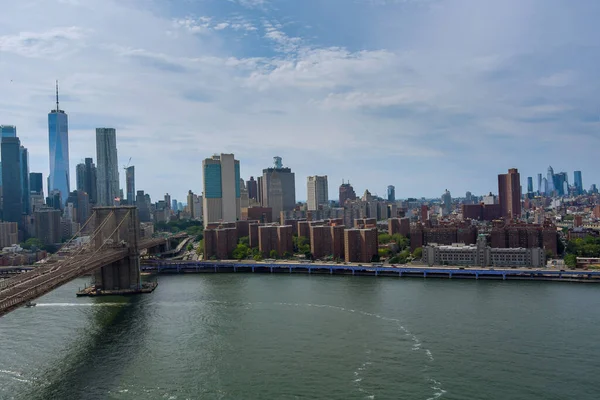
0,206 -> 186,316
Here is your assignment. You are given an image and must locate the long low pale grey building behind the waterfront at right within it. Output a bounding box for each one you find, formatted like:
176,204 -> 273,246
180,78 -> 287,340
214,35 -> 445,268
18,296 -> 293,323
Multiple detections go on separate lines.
423,235 -> 546,268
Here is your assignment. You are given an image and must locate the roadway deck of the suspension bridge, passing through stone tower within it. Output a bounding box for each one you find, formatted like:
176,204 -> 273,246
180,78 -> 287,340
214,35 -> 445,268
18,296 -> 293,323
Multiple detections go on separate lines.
0,238 -> 176,317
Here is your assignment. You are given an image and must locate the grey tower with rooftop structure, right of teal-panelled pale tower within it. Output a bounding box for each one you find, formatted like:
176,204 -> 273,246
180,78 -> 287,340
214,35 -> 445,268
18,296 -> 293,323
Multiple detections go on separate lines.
261,157 -> 296,221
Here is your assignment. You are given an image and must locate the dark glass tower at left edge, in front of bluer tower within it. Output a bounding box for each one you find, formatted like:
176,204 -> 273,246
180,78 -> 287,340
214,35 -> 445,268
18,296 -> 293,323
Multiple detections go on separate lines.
0,137 -> 23,224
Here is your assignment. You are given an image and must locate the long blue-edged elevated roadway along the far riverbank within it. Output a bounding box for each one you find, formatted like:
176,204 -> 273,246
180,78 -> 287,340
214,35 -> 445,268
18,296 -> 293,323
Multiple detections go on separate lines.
141,260 -> 600,283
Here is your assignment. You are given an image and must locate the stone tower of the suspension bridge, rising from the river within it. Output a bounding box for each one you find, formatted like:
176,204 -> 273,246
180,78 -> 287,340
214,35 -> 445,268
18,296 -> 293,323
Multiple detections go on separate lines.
94,206 -> 141,290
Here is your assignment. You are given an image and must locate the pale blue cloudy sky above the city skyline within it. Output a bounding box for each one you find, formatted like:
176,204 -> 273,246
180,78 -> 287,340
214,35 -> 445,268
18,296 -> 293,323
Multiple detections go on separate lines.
0,0 -> 600,202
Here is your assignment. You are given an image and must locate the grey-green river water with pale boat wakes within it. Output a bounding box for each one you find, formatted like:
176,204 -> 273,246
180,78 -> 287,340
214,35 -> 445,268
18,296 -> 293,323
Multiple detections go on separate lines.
0,274 -> 600,400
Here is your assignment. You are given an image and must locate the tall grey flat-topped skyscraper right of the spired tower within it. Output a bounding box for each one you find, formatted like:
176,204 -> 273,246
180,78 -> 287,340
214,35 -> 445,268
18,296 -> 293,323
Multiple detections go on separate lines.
96,128 -> 119,206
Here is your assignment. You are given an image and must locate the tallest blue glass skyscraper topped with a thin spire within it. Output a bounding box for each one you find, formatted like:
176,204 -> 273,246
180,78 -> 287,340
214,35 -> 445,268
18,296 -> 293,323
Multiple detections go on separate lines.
48,81 -> 70,206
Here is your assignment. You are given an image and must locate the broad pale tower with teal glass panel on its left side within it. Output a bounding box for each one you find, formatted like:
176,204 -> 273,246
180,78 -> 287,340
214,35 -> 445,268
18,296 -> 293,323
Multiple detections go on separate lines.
202,154 -> 241,227
